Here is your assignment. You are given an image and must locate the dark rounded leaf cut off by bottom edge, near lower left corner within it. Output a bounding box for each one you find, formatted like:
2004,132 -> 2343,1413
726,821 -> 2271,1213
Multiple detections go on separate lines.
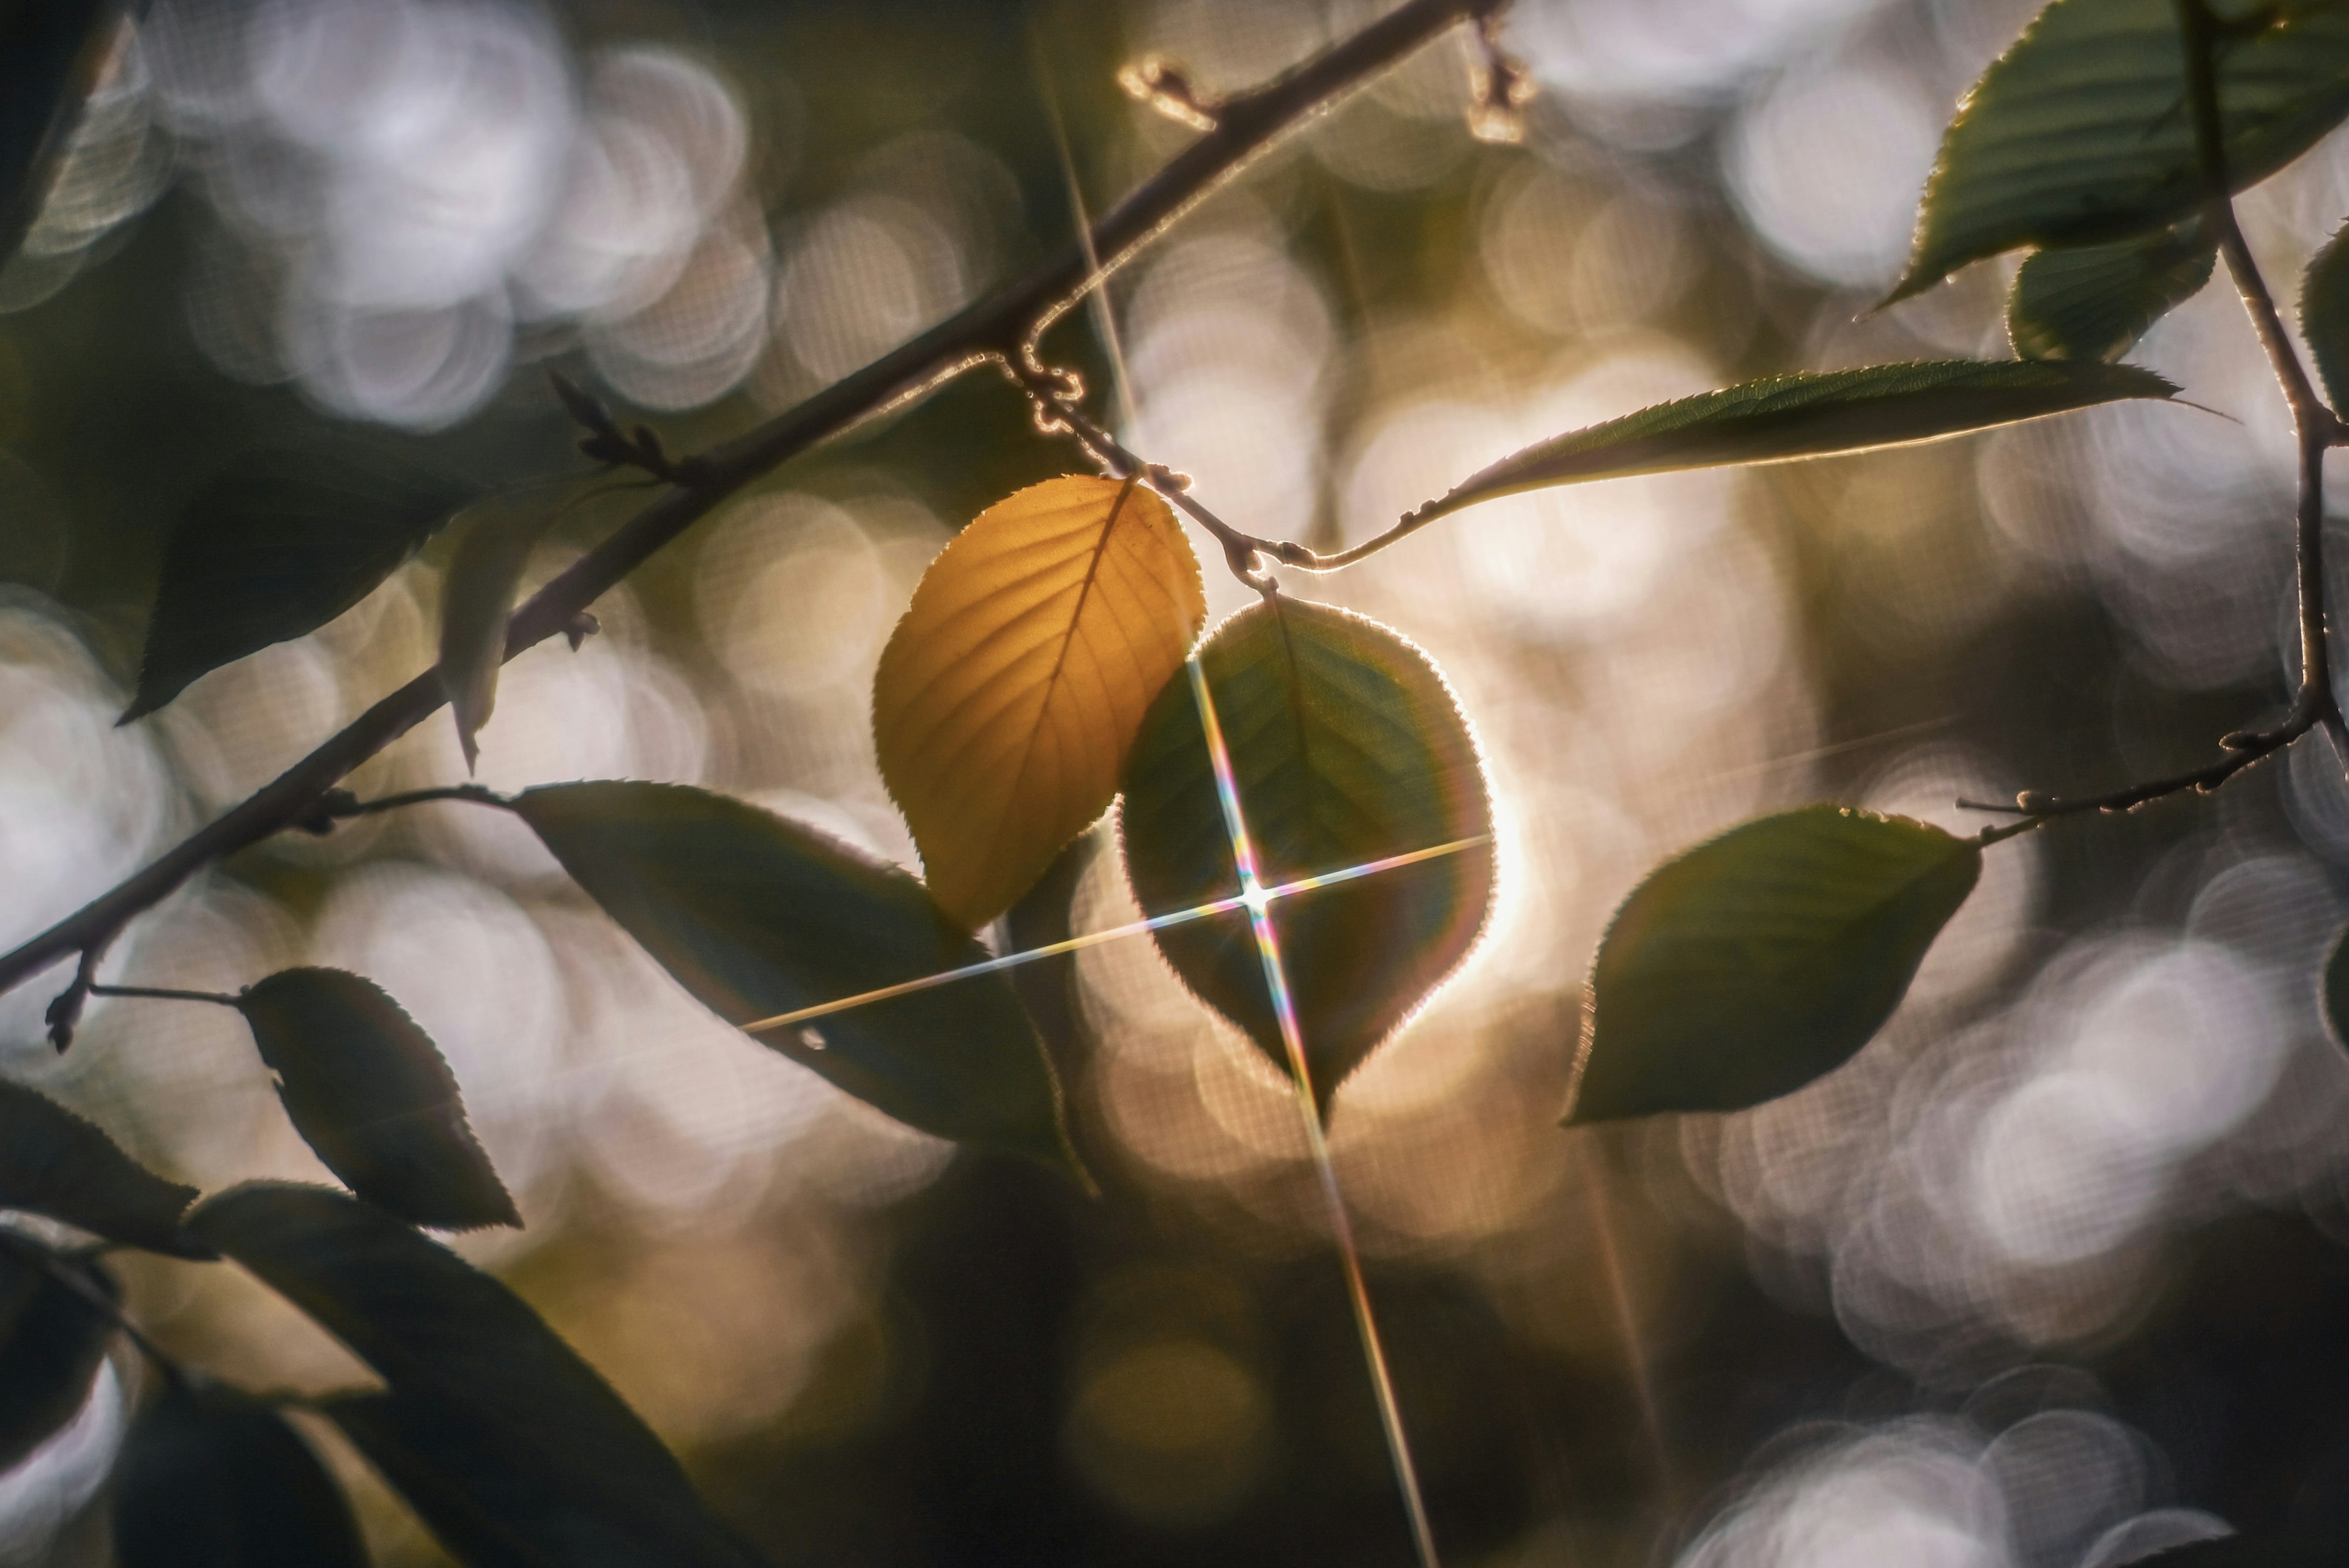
113,1383 -> 366,1568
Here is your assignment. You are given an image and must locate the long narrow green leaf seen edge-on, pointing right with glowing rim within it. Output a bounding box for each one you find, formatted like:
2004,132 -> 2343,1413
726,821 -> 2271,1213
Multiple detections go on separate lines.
1402,359 -> 2178,528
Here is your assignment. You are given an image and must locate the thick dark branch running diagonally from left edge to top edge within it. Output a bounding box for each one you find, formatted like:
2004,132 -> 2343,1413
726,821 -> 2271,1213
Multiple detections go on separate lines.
0,0 -> 1501,1028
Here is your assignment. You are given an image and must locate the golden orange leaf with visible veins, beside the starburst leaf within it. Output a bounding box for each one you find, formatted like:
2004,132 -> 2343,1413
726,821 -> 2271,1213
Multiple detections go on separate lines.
874,474 -> 1208,930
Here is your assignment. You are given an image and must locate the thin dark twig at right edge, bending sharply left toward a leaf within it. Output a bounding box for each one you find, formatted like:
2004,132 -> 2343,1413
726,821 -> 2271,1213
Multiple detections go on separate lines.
1959,0 -> 2349,845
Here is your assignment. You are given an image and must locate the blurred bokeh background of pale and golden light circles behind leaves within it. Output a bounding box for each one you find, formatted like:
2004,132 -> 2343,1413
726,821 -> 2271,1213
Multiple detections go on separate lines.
0,0 -> 2349,1568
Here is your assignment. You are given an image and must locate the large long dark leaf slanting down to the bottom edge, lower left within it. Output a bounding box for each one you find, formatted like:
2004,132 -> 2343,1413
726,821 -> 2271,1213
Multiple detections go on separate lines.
188,1183 -> 749,1568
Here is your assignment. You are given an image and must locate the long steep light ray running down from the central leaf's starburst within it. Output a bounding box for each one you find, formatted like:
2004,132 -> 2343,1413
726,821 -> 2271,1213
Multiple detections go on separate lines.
1186,655 -> 1438,1568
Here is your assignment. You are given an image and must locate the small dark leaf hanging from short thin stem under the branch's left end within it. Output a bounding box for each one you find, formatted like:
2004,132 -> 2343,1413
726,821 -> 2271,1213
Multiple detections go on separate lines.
237,969 -> 521,1230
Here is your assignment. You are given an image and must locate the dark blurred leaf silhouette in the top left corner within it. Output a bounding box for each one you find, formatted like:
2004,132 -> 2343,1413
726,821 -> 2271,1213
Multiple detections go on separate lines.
0,0 -> 122,263
